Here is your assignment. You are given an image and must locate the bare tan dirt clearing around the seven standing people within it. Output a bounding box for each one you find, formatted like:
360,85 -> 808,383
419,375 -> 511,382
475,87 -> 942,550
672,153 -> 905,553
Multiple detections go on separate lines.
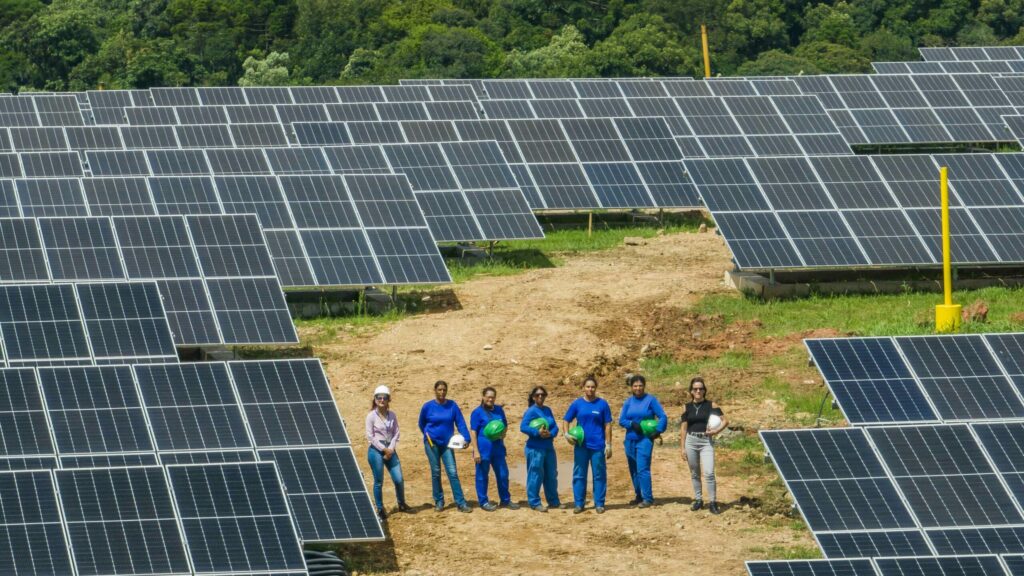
303,234 -> 815,576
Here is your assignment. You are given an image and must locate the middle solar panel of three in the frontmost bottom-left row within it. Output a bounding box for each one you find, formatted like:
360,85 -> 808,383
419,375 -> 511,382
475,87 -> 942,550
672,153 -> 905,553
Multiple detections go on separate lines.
55,466 -> 190,576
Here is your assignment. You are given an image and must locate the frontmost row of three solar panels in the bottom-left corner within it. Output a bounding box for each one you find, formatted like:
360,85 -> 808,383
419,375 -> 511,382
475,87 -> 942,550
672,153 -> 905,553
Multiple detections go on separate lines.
0,462 -> 308,576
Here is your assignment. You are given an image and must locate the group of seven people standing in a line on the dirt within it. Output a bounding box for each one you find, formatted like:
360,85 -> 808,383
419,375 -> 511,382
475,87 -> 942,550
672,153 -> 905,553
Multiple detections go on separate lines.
366,374 -> 728,520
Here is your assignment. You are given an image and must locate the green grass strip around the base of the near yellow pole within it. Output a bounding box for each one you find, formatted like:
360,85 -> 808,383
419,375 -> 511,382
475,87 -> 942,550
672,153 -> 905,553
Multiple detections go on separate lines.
694,287 -> 1024,336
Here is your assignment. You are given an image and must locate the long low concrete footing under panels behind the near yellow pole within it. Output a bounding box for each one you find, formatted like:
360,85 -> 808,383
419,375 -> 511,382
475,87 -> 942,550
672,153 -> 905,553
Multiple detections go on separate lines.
725,271 -> 1024,300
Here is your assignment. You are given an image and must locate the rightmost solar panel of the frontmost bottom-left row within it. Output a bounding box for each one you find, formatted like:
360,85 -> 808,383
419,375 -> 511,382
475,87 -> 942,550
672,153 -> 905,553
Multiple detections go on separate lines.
167,462 -> 305,573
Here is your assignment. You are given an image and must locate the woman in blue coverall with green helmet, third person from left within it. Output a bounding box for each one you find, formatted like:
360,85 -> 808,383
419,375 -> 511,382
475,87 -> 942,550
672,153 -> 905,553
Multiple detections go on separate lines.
469,386 -> 519,512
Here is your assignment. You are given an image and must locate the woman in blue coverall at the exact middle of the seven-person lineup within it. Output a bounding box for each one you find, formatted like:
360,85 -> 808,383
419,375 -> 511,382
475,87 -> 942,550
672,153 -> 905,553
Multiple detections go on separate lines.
519,386 -> 561,512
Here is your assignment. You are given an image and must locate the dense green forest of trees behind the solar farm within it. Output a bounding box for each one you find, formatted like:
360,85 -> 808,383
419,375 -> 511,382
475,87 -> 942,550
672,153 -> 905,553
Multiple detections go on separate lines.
0,0 -> 1024,91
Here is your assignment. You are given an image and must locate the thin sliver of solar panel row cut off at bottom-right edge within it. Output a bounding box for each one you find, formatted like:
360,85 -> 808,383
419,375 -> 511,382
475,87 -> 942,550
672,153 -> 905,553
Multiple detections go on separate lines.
746,554 -> 1024,576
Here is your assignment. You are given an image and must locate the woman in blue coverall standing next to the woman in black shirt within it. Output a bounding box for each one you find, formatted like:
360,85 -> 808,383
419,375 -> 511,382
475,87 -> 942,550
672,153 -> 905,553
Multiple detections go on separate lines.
618,374 -> 669,502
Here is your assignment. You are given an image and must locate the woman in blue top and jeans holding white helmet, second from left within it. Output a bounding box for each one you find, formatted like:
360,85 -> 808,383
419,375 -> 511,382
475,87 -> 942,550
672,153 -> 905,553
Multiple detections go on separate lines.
420,380 -> 473,512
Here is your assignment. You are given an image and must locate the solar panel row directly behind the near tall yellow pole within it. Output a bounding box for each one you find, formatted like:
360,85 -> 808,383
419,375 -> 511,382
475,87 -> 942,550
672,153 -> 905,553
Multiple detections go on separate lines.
685,154 -> 1024,270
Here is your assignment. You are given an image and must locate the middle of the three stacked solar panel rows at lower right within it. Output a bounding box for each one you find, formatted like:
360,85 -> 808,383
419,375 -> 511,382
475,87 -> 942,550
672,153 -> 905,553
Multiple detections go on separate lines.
761,422 -> 1024,558
